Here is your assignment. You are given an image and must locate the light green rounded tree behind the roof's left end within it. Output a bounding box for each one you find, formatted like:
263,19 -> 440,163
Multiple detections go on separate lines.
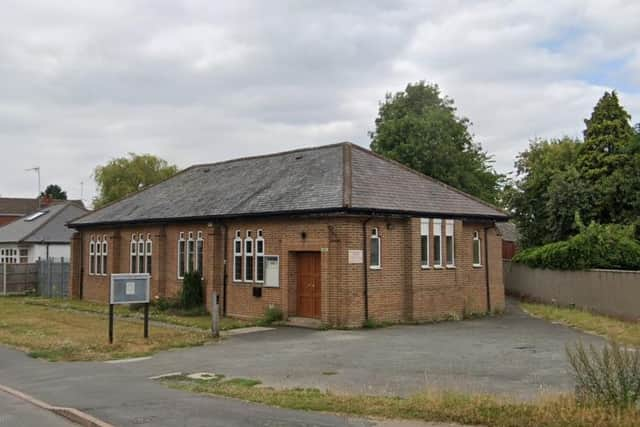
93,153 -> 178,208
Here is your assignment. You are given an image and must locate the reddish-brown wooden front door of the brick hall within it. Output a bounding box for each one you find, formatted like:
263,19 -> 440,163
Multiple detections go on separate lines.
296,252 -> 322,319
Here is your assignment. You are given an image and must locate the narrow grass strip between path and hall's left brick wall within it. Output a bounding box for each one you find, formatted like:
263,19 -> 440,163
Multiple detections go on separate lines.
20,297 -> 256,331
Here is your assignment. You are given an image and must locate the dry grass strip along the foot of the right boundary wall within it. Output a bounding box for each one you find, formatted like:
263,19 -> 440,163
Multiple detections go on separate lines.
520,302 -> 640,347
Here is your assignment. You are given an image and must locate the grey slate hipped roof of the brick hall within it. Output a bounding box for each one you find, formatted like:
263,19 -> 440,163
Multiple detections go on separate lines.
69,143 -> 507,227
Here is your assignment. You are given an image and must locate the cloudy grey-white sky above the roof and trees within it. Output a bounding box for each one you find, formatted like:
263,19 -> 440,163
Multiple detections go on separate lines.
0,0 -> 640,206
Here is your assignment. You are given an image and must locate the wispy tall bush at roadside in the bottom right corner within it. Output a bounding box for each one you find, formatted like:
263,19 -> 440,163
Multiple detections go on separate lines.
567,341 -> 640,408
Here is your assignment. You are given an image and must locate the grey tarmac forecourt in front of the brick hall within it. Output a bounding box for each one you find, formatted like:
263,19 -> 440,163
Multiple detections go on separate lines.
131,301 -> 602,399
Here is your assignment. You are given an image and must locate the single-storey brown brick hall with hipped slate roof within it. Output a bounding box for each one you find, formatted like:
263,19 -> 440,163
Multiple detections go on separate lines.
69,143 -> 508,326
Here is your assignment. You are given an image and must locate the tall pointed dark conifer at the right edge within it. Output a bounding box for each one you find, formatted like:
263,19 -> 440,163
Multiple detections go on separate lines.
578,91 -> 640,224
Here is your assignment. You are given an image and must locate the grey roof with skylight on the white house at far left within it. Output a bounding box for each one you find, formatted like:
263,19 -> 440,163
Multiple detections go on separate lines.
0,201 -> 87,243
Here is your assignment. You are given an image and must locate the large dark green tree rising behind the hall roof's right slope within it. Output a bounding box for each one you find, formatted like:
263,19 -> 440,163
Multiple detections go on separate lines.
369,81 -> 504,207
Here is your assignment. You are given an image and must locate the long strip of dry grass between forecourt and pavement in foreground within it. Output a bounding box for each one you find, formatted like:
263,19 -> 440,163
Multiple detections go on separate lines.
163,377 -> 640,427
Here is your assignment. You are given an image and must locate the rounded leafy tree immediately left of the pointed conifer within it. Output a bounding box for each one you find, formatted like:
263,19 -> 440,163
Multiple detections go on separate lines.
505,137 -> 588,247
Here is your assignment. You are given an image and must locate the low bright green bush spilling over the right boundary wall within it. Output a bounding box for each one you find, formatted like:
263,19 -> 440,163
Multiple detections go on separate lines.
513,223 -> 640,270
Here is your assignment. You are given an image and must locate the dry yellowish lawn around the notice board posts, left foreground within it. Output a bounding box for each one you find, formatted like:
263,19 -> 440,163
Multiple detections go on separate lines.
0,297 -> 210,361
